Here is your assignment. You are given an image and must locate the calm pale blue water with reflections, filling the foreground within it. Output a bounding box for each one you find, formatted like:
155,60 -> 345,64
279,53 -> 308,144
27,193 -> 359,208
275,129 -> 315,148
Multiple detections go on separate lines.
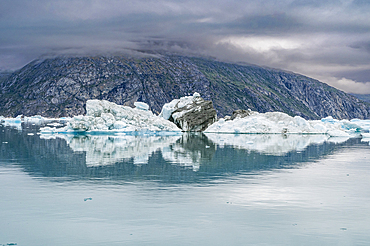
0,126 -> 370,246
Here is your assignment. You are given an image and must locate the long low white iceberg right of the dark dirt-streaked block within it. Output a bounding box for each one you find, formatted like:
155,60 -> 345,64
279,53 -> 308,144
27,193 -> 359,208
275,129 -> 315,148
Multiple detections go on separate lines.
205,112 -> 370,137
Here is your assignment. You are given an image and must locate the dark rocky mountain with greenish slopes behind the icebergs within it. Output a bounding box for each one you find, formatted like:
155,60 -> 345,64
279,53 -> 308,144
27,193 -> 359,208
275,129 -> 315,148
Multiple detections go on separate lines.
0,55 -> 370,119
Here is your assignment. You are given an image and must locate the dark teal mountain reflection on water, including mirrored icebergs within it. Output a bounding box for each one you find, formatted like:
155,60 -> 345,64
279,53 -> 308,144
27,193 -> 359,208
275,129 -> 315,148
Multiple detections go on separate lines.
0,127 -> 366,182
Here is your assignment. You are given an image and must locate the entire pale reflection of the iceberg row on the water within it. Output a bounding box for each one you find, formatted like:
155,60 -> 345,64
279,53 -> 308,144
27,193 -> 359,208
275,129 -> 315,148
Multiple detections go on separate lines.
47,133 -> 348,171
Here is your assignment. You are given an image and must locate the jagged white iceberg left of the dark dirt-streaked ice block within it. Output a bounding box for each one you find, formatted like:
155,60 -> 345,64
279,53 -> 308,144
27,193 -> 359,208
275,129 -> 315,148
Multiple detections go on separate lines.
40,100 -> 181,134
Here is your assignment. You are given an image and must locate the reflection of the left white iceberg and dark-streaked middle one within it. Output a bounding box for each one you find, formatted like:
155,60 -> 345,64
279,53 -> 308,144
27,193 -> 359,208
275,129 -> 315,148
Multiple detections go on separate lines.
52,133 -> 215,171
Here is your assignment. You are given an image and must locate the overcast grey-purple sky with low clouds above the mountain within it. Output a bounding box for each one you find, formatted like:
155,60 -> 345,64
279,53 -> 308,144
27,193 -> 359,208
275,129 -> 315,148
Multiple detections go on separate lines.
0,0 -> 370,93
